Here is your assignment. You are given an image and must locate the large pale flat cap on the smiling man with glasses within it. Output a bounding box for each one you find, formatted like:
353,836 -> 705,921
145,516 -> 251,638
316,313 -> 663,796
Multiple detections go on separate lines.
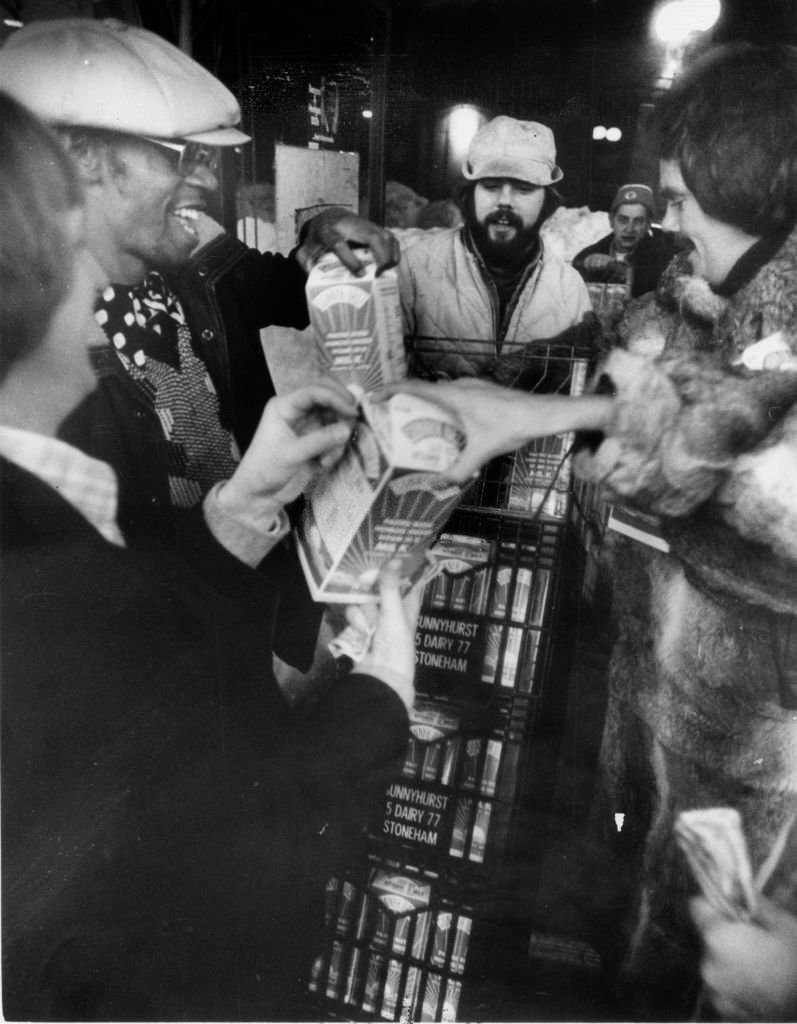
0,17 -> 249,145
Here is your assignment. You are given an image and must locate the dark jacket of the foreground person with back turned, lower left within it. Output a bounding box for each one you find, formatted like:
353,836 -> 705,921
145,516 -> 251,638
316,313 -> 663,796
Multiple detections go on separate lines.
0,461 -> 408,1021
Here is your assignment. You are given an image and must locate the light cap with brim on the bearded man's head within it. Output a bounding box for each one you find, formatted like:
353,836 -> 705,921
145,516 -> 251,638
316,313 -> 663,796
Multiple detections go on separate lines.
462,115 -> 564,185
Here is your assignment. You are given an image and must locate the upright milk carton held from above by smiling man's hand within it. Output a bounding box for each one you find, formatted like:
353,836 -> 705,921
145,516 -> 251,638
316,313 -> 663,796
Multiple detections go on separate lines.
305,250 -> 407,397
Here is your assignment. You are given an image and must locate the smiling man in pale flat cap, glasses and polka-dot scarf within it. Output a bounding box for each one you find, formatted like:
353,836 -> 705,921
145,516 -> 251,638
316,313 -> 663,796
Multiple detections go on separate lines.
0,18 -> 399,668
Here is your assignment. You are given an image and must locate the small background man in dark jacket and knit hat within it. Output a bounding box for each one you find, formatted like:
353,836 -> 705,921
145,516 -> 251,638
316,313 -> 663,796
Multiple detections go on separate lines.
573,183 -> 678,298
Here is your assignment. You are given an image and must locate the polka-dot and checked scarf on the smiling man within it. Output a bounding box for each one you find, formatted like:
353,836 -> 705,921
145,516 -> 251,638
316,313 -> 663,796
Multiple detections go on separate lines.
94,271 -> 240,508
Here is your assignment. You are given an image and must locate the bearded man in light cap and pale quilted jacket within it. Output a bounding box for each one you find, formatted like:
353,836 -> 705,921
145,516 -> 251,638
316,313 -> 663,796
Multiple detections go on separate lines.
400,116 -> 591,378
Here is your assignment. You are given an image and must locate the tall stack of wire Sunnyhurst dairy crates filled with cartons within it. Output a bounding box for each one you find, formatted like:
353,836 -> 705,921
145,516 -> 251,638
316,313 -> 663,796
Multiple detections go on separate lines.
304,258 -> 586,1021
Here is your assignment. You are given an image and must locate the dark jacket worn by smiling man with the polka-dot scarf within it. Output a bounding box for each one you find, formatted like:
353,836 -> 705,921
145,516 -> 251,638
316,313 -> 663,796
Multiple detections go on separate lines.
58,234 -> 320,669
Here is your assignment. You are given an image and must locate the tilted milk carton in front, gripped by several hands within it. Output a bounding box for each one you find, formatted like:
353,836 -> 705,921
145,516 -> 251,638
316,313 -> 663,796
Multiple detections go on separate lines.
296,394 -> 465,603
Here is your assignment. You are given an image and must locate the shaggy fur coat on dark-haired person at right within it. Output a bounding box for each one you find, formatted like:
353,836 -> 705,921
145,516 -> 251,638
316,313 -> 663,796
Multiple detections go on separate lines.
574,222 -> 797,1019
